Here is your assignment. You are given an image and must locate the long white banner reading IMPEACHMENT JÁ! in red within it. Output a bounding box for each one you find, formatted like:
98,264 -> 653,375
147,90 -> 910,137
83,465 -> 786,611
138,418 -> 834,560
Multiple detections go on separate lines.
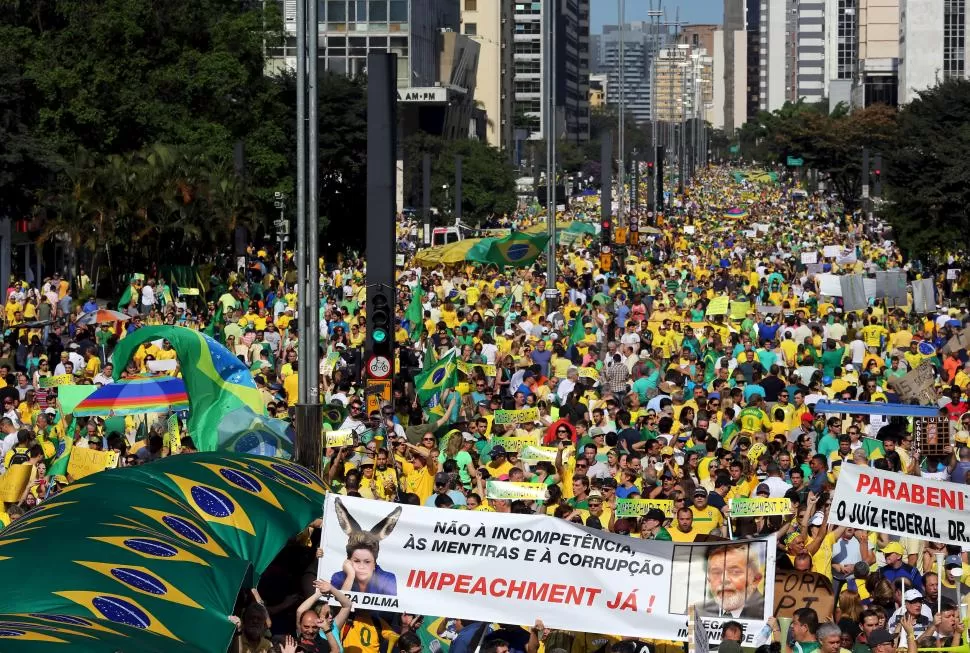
318,494 -> 775,645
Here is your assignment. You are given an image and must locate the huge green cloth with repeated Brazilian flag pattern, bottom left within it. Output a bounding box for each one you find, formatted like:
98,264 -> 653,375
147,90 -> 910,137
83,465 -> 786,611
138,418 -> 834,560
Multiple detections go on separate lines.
0,452 -> 325,653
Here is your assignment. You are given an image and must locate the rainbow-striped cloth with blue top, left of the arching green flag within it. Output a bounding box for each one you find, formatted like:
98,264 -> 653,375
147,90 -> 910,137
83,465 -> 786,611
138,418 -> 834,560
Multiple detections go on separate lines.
74,376 -> 189,417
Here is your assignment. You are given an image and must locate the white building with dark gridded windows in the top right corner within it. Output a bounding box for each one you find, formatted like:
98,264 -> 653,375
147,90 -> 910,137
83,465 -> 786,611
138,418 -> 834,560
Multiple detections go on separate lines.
898,0 -> 968,104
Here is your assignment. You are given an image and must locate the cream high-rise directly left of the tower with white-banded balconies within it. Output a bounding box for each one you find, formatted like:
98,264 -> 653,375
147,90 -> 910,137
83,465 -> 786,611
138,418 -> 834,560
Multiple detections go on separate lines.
460,0 -> 515,151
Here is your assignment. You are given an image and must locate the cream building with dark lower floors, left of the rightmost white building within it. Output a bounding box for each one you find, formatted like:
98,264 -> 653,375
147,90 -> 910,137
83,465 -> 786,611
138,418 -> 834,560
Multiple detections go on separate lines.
852,0 -> 899,107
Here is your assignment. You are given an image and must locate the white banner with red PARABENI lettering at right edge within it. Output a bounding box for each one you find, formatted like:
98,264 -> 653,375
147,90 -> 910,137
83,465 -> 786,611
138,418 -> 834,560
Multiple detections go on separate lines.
829,464 -> 970,546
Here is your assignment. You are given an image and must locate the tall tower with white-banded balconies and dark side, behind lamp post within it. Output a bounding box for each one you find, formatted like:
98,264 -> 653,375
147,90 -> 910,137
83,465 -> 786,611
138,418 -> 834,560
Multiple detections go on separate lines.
516,0 -> 590,142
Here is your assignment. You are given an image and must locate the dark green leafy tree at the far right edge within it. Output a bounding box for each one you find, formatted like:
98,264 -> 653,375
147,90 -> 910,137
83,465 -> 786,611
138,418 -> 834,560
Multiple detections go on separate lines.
882,80 -> 970,255
